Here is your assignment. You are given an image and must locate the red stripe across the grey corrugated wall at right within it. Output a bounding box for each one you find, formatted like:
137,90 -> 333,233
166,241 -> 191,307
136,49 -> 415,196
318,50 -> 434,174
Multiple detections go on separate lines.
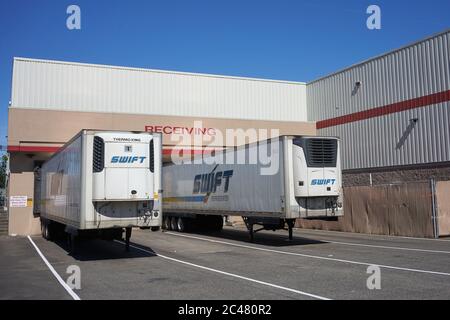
316,90 -> 450,129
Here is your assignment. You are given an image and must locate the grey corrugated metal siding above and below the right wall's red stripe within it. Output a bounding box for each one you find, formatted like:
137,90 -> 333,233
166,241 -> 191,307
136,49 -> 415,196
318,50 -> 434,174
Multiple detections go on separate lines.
307,31 -> 450,169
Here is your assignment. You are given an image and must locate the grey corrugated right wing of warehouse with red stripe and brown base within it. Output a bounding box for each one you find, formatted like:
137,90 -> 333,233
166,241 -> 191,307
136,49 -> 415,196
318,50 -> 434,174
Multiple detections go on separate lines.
299,30 -> 450,237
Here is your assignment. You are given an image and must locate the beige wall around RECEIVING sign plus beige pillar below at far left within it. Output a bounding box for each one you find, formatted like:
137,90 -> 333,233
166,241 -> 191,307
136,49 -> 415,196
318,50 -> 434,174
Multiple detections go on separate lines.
8,108 -> 316,235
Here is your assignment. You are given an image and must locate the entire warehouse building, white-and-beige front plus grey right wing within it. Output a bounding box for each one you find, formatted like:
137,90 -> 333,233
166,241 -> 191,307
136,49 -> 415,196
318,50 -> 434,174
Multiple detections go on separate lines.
4,31 -> 450,236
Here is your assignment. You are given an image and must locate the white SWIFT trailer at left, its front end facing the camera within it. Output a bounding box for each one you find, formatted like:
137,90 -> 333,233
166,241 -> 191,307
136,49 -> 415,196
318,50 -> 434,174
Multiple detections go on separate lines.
35,130 -> 162,250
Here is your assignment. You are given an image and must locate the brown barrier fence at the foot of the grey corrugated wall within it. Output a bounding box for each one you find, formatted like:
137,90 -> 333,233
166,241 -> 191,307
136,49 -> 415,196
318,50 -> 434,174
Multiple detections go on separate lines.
296,182 -> 436,238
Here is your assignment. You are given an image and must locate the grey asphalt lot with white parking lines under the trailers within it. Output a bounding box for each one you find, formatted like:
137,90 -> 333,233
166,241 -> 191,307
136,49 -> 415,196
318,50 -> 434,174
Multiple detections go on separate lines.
0,227 -> 450,300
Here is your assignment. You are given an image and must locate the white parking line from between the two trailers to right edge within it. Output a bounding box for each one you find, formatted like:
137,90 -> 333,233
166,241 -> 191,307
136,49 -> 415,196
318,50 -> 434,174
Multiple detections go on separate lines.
165,232 -> 450,276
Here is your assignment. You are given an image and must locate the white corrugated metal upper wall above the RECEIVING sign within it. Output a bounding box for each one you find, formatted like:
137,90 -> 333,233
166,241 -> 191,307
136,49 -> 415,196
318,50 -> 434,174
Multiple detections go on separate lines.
12,58 -> 307,121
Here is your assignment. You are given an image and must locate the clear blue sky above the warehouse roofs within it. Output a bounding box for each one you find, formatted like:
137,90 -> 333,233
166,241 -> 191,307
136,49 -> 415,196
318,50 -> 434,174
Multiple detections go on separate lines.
0,0 -> 450,155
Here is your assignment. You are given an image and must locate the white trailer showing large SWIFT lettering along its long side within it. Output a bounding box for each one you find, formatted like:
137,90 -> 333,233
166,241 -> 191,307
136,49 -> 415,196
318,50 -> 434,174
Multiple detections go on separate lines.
163,136 -> 344,240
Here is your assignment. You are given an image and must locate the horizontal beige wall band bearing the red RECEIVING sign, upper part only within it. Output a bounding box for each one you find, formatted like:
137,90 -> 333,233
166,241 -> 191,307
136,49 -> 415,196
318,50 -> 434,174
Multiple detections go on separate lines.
8,108 -> 316,146
